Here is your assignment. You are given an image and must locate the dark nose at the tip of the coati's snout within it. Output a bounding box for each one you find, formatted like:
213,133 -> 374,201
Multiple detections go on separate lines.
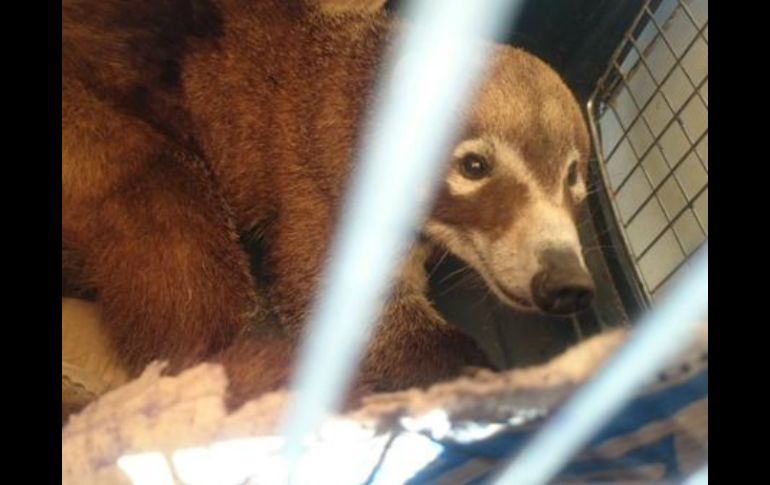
532,251 -> 594,315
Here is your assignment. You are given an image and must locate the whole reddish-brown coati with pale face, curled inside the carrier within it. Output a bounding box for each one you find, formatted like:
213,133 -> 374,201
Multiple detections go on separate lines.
62,0 -> 592,408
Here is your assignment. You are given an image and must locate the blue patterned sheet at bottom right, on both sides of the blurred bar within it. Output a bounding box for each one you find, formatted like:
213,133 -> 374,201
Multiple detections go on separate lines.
402,363 -> 708,485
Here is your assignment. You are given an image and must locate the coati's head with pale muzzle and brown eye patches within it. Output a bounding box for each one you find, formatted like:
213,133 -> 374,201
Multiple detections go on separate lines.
425,47 -> 594,314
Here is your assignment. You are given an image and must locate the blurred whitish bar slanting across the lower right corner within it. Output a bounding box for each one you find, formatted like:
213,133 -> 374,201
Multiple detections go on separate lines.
493,245 -> 708,485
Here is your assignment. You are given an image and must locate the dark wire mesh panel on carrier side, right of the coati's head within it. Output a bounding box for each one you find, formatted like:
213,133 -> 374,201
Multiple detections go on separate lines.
590,0 -> 708,300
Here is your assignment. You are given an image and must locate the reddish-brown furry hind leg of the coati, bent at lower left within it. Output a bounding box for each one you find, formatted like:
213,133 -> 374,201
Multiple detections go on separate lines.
64,151 -> 256,372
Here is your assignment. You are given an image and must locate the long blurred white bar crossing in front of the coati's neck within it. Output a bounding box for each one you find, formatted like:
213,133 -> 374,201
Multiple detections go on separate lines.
283,0 -> 522,476
